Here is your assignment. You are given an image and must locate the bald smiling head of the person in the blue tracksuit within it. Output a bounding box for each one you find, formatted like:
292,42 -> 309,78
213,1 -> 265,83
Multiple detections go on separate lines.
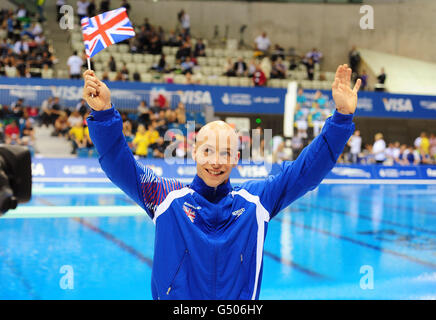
192,121 -> 240,188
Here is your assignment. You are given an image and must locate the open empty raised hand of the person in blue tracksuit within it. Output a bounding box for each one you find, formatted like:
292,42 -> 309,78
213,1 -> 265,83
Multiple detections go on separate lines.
332,64 -> 362,114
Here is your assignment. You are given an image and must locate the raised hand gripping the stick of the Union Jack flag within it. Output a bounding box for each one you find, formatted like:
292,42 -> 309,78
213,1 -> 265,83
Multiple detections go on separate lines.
83,70 -> 112,111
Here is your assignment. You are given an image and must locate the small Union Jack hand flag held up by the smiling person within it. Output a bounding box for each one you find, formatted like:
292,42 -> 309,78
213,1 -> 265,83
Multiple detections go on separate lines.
80,7 -> 135,58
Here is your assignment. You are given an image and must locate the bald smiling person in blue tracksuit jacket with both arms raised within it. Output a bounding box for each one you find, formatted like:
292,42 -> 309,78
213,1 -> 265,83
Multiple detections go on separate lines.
83,65 -> 360,299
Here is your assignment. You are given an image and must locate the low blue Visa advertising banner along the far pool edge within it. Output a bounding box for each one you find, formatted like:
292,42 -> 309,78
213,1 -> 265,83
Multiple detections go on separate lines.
32,158 -> 436,184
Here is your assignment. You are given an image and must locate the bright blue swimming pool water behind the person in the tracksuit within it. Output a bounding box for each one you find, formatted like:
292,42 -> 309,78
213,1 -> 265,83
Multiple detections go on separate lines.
0,183 -> 436,300
